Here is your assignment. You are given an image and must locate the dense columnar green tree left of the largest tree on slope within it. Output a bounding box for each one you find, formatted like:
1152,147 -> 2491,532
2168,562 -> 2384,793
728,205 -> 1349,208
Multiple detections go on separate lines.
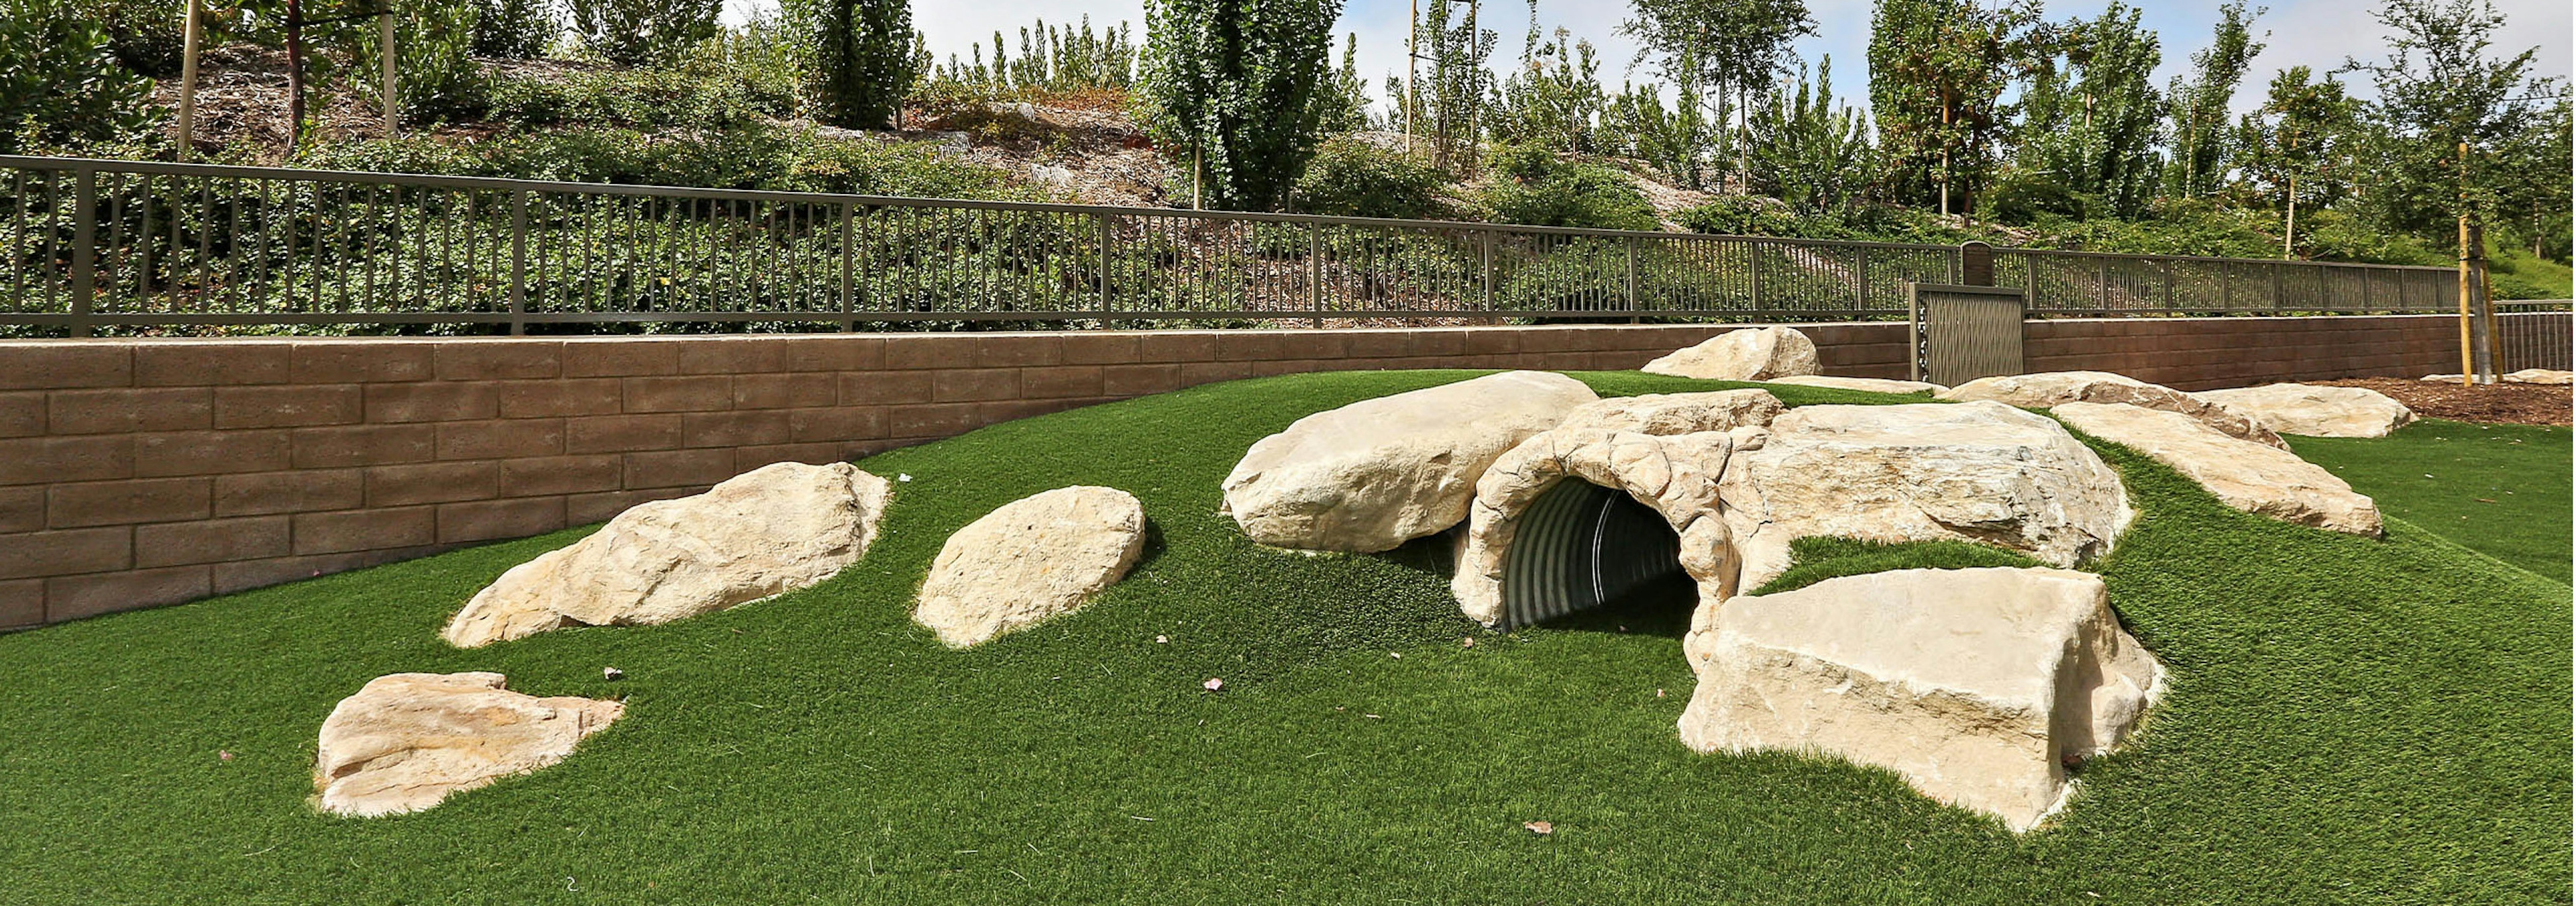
788,0 -> 922,129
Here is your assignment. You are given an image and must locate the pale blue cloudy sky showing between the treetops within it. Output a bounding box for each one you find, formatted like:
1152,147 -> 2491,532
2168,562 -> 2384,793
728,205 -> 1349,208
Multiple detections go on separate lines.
729,0 -> 2576,108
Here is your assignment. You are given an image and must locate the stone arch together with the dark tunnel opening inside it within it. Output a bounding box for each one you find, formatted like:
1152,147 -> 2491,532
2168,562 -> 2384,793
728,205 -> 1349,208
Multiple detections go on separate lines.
1450,427 -> 1739,628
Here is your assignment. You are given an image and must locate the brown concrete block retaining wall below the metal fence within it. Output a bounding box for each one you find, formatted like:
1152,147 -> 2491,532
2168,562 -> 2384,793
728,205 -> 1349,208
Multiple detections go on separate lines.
0,317 -> 2457,628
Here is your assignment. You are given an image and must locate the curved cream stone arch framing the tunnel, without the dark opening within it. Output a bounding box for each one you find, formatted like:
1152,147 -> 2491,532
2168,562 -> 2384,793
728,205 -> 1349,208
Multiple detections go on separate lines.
1450,427 -> 1739,625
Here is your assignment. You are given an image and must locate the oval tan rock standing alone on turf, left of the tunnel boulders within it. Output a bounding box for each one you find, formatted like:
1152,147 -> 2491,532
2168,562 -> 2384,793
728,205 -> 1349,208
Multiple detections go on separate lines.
912,487 -> 1144,648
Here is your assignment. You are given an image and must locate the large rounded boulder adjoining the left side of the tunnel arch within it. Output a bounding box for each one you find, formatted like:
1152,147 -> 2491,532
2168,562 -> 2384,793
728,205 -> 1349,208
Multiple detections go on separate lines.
1224,370 -> 1600,554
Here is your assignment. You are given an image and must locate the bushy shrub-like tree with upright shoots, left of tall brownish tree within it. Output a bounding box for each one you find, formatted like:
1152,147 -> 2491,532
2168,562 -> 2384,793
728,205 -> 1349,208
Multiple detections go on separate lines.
1744,56 -> 1870,213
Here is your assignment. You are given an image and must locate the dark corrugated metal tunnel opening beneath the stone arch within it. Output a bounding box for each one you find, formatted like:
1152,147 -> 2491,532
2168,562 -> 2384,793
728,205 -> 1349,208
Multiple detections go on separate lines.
1499,479 -> 1698,631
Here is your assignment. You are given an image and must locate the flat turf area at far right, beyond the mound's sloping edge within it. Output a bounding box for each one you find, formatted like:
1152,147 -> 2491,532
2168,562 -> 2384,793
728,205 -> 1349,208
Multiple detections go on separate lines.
2288,422 -> 2571,582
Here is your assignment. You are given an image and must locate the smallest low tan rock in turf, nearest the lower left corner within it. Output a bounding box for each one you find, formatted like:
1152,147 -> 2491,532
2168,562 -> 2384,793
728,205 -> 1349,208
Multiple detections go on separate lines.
314,672 -> 626,819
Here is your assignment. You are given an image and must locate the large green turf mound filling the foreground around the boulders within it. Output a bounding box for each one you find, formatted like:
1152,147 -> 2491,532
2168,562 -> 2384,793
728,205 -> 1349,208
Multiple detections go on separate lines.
0,370 -> 2571,903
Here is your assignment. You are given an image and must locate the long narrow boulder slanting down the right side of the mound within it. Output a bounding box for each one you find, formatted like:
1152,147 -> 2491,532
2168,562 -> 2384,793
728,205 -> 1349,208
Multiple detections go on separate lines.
2048,401 -> 2380,536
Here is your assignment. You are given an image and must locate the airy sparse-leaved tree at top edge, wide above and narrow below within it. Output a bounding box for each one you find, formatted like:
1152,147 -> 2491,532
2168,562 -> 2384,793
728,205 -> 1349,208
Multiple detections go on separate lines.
1620,0 -> 1816,183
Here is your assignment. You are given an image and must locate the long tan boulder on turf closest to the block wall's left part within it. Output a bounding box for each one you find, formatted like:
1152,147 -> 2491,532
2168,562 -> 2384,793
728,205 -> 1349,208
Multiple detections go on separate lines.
445,463 -> 889,648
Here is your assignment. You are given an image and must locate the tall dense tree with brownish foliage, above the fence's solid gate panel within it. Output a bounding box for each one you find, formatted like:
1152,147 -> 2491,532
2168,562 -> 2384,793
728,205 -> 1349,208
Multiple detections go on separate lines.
1870,0 -> 2040,213
